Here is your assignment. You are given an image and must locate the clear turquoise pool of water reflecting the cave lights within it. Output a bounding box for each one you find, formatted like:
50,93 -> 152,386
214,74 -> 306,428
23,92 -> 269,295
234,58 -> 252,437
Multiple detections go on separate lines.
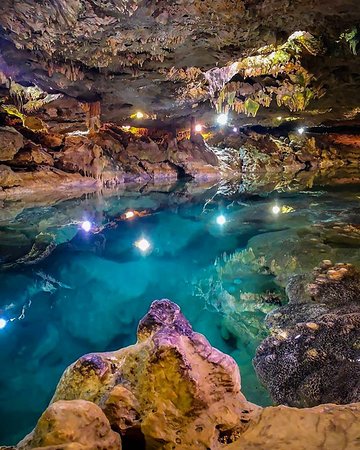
0,176 -> 360,444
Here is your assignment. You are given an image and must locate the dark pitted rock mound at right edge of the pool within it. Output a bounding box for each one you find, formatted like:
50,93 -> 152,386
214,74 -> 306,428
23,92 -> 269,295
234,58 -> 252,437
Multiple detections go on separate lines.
254,261 -> 360,407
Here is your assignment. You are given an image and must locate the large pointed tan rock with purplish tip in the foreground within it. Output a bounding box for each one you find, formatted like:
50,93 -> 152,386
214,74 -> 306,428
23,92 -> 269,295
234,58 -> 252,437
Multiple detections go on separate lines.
53,300 -> 258,450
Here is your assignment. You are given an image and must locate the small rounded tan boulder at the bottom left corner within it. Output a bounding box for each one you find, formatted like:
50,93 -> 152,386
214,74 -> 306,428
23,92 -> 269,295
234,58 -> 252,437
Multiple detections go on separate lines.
17,400 -> 121,450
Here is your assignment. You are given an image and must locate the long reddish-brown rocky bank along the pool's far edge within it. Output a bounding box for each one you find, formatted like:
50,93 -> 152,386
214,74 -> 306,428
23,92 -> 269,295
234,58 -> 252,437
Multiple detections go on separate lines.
0,119 -> 360,199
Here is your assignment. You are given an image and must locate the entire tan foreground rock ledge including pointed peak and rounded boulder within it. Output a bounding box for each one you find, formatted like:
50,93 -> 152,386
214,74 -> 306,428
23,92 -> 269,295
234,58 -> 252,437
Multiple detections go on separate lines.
4,300 -> 360,450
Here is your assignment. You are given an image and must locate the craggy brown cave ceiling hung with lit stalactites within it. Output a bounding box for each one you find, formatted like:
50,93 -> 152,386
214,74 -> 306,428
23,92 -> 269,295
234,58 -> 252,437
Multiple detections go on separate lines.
0,0 -> 360,125
